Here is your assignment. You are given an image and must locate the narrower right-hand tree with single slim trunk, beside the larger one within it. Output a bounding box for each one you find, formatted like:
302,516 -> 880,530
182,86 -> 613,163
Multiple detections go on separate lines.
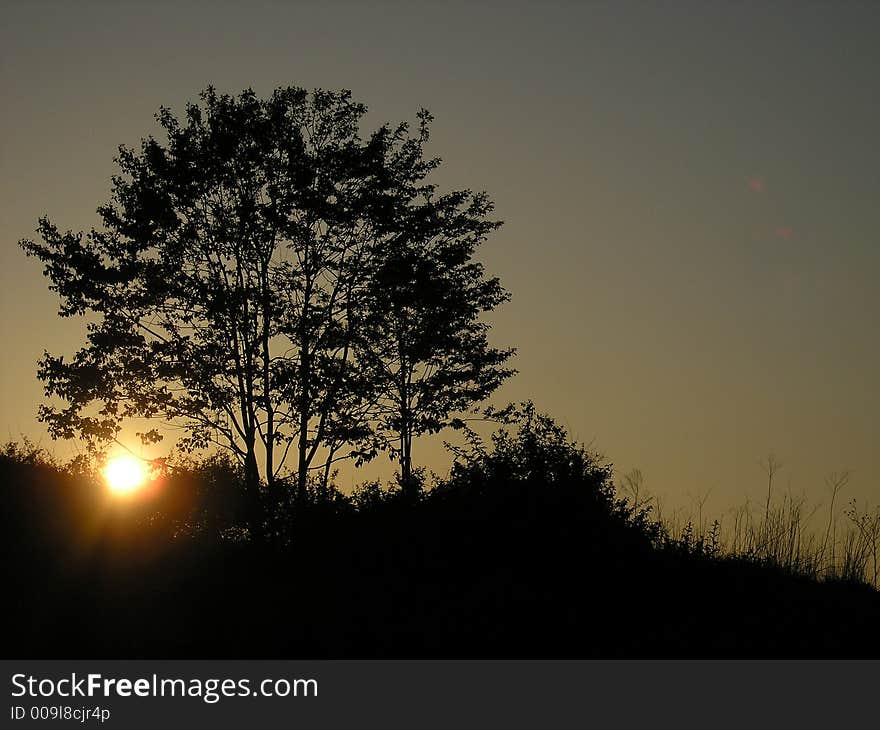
357,185 -> 514,494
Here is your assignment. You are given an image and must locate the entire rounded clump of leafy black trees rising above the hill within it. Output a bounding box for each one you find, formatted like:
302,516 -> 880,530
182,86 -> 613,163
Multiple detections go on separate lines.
20,87 -> 510,534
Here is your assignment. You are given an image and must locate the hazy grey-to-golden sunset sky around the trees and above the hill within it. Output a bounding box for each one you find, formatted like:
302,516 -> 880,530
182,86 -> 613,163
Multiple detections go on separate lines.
0,0 -> 880,513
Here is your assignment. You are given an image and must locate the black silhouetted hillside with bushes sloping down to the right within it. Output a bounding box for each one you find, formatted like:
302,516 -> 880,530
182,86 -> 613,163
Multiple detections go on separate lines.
0,422 -> 880,658
